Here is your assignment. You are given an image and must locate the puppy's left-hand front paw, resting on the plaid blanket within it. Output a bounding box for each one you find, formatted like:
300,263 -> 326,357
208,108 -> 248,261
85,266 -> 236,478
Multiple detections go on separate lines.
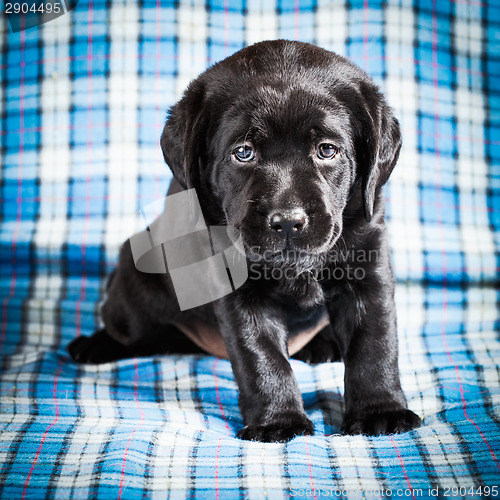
238,415 -> 314,443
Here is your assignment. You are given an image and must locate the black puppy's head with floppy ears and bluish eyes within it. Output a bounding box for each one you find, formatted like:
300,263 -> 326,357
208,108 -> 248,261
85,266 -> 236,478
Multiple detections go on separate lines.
161,41 -> 401,266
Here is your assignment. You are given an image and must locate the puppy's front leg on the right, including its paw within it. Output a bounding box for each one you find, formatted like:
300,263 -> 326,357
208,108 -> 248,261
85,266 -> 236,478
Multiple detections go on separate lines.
328,273 -> 420,435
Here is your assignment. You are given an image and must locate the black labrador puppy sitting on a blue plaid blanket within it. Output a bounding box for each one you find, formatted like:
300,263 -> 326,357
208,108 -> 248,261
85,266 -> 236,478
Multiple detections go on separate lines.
69,40 -> 420,441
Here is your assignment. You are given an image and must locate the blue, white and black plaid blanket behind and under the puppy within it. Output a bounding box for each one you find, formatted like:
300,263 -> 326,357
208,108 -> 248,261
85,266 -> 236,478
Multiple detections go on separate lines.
0,0 -> 500,499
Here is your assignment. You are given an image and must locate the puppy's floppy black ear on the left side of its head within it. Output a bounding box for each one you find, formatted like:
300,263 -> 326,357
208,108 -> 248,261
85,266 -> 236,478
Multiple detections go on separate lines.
160,80 -> 207,189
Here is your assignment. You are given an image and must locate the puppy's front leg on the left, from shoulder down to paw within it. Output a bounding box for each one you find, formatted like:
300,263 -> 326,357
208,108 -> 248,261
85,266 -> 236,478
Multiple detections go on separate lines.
214,289 -> 313,442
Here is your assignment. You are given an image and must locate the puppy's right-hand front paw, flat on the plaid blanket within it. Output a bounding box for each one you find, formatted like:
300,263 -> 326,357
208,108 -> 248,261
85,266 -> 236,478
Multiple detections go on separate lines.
342,409 -> 422,436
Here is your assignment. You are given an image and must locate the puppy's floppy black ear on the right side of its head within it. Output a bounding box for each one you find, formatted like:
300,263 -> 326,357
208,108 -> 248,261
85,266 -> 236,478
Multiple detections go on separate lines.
357,87 -> 402,222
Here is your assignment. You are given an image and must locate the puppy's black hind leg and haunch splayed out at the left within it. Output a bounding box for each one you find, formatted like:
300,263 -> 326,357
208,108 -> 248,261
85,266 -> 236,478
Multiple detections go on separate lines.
68,236 -> 204,363
